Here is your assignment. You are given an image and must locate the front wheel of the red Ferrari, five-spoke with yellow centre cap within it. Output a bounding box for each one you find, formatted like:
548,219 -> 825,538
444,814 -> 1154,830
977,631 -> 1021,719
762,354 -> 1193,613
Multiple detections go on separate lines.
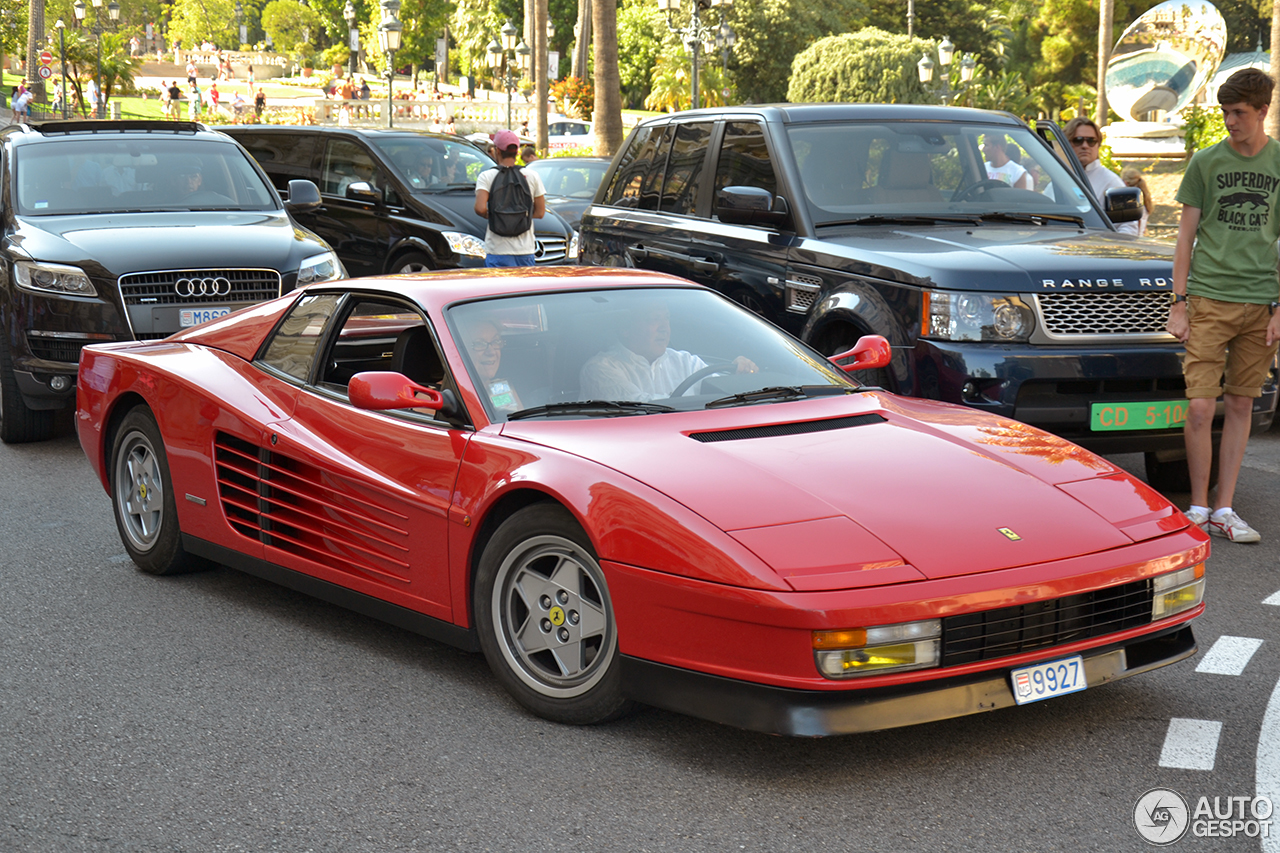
474,503 -> 632,725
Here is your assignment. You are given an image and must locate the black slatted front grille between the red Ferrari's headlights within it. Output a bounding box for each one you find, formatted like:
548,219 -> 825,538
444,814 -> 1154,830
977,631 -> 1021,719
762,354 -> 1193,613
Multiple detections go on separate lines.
942,580 -> 1152,666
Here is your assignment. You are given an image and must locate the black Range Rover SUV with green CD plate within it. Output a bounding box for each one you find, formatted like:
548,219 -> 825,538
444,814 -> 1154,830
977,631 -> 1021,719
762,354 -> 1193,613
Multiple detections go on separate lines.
581,104 -> 1277,489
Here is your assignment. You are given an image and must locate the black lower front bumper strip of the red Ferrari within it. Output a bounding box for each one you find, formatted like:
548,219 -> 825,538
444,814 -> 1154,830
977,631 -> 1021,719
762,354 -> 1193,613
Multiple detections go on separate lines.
622,622 -> 1197,738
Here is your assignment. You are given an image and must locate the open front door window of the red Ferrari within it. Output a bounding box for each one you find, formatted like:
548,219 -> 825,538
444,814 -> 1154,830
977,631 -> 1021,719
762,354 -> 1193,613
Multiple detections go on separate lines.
319,298 -> 445,416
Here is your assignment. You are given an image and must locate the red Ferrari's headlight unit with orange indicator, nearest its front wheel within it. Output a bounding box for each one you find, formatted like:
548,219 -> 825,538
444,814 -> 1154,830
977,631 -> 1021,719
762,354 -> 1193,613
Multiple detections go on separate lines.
813,619 -> 942,679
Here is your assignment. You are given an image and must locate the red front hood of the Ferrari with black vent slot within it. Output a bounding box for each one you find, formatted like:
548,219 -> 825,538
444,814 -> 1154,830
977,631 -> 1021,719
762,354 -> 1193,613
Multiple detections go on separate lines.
503,393 -> 1185,580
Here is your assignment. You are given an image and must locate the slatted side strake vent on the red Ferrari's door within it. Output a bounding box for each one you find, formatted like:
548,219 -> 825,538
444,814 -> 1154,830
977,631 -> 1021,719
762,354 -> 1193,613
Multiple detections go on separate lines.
214,433 -> 410,584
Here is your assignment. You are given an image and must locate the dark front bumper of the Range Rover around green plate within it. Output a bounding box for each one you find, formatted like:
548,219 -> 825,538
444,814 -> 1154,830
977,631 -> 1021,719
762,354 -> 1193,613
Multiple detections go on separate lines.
910,339 -> 1280,453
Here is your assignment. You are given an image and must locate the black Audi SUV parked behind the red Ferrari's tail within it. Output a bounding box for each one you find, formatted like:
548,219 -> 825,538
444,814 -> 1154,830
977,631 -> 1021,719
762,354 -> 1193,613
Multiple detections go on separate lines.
0,120 -> 346,442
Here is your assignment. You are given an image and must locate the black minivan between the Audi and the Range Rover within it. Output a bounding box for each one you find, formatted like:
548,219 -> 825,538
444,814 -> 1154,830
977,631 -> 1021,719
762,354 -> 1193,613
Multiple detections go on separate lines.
221,124 -> 577,277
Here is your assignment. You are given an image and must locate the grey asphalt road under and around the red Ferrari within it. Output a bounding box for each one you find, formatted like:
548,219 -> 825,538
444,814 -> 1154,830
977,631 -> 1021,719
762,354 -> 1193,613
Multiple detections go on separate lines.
0,409 -> 1280,853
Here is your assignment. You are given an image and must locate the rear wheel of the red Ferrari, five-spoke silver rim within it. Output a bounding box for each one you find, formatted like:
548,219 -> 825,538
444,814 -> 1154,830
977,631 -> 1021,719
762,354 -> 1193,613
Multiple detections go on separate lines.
109,407 -> 210,575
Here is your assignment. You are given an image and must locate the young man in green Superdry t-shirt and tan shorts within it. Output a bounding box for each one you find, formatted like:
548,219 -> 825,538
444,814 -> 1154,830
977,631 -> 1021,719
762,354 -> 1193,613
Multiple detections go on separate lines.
1167,68 -> 1280,542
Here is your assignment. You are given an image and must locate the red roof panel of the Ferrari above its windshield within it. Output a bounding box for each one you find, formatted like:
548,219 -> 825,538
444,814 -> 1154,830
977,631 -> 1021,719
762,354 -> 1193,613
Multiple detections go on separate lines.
306,266 -> 707,311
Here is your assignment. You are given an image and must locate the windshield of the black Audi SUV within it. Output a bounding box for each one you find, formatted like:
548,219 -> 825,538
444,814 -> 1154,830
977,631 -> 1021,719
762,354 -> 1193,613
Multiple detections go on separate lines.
14,133 -> 279,216
